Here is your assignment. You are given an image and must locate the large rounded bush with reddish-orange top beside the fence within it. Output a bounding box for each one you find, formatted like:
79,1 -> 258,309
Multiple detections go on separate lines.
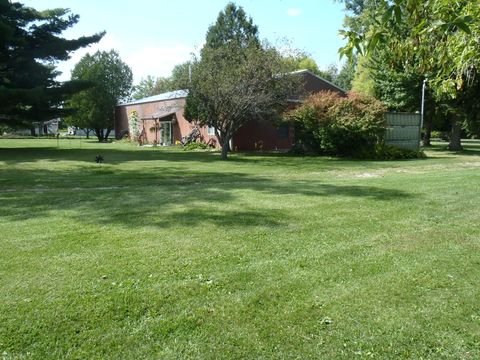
287,92 -> 386,158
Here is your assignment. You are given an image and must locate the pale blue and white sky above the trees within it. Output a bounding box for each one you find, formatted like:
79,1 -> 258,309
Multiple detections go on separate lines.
19,0 -> 345,84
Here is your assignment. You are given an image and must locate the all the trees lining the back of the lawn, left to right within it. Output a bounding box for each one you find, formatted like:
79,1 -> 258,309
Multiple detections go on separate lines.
8,0 -> 480,158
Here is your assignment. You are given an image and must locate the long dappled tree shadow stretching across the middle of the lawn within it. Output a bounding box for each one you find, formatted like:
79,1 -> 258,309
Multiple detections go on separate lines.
0,167 -> 413,228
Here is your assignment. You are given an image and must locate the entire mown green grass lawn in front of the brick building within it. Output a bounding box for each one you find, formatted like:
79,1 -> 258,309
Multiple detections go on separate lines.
0,139 -> 480,359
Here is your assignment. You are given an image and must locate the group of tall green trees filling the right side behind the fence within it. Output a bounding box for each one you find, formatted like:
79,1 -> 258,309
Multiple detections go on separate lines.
340,0 -> 480,150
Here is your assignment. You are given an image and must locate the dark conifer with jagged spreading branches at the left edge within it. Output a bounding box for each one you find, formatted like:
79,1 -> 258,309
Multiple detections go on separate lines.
0,0 -> 103,126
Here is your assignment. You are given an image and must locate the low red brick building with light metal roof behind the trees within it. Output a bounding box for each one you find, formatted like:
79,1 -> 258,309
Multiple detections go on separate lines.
115,70 -> 345,151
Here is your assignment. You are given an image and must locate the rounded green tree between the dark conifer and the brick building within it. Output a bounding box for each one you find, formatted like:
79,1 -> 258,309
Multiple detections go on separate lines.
69,50 -> 133,141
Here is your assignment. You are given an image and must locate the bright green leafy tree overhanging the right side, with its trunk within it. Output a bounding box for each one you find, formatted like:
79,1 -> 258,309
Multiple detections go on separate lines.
341,0 -> 480,150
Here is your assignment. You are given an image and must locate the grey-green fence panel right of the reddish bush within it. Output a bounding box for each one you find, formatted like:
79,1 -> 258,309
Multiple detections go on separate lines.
385,113 -> 421,151
